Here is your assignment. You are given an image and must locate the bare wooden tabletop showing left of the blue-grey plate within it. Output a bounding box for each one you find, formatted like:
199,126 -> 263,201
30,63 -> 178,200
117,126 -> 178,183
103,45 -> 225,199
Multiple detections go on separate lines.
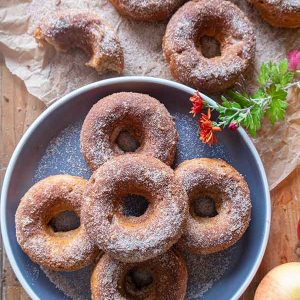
0,56 -> 45,300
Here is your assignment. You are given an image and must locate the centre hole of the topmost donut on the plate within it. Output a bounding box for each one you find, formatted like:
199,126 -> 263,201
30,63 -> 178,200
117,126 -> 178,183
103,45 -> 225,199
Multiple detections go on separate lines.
115,129 -> 141,153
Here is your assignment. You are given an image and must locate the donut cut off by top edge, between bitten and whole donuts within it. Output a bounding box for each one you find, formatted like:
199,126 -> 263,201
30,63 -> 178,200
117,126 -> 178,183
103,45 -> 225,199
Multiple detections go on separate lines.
109,0 -> 185,22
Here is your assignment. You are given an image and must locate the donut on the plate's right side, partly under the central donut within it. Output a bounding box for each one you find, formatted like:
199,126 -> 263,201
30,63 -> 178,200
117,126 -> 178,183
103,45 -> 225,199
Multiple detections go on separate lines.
175,158 -> 251,254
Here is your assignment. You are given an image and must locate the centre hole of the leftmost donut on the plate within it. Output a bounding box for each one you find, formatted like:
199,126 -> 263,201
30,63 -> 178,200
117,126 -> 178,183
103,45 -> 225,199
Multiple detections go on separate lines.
48,210 -> 80,233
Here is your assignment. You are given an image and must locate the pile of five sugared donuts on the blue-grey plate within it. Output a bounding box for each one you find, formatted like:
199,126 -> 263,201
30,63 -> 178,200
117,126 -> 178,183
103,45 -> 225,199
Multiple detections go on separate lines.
15,92 -> 251,300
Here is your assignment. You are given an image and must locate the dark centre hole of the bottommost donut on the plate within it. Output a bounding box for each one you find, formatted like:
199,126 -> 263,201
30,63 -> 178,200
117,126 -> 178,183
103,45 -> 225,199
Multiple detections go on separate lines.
125,267 -> 154,297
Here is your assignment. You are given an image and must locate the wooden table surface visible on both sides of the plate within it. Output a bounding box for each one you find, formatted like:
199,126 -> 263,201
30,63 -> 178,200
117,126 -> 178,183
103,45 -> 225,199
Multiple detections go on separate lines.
0,54 -> 300,300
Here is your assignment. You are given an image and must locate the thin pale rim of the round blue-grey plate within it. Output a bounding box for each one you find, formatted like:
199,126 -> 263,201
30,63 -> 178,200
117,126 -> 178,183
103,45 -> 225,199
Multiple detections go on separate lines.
0,76 -> 271,300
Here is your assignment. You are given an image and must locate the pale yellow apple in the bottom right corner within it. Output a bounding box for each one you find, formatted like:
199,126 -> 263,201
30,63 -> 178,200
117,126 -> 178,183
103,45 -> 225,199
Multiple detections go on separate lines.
254,262 -> 300,300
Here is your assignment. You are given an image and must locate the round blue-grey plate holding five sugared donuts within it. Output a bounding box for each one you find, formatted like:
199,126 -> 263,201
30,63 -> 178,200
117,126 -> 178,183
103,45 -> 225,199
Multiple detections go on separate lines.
1,77 -> 271,300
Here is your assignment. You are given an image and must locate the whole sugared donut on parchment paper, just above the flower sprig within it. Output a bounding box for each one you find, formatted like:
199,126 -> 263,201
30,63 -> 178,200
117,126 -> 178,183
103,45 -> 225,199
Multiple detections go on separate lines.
163,0 -> 256,93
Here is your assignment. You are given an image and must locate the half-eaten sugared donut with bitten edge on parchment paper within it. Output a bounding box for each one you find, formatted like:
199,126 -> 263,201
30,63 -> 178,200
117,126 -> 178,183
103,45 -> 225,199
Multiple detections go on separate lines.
34,12 -> 124,73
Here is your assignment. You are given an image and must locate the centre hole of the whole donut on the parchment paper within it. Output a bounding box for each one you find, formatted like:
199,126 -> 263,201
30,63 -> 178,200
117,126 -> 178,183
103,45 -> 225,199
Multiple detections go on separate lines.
196,35 -> 221,58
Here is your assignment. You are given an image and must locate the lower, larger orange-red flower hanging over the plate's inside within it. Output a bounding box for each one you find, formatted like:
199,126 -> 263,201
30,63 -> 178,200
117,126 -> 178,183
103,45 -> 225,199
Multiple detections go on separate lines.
199,109 -> 222,146
